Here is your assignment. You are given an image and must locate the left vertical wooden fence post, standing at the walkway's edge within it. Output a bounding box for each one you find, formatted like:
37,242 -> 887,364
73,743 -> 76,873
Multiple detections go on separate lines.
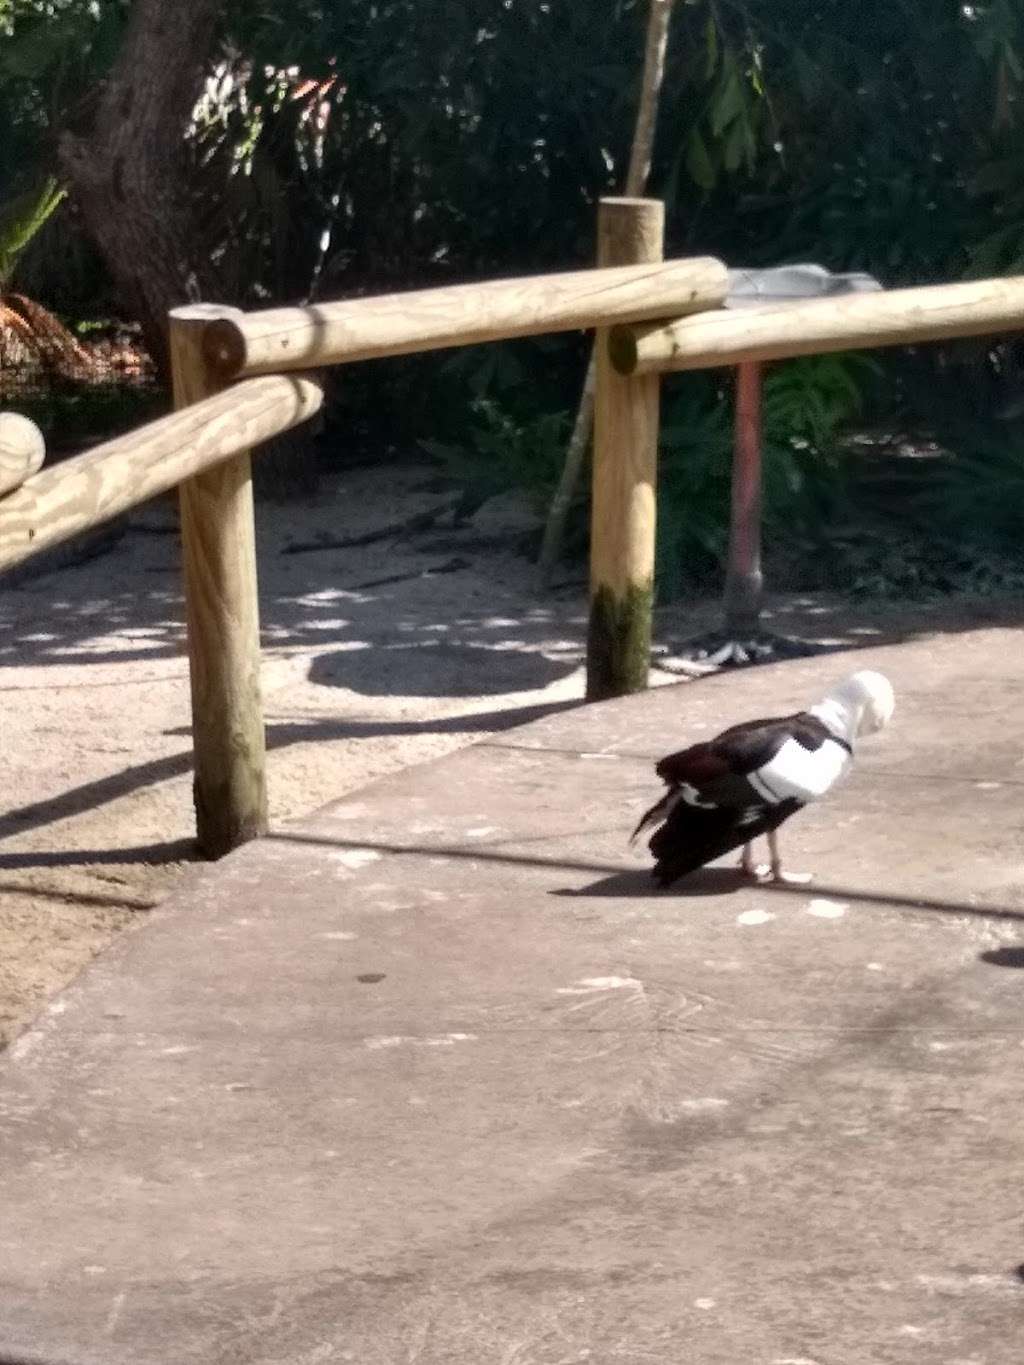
171,304 -> 266,857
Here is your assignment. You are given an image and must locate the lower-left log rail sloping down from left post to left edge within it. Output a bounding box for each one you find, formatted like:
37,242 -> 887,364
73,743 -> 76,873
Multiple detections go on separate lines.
0,375 -> 324,569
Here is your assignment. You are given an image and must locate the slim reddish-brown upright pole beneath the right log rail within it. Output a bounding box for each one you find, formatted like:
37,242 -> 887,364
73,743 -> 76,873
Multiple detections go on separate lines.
725,360 -> 763,636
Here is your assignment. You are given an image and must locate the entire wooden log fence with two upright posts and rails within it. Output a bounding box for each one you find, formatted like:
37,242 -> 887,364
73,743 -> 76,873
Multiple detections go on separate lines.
0,199 -> 1024,857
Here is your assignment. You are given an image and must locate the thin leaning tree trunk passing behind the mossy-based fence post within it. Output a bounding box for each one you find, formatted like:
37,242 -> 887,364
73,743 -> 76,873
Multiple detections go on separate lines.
537,0 -> 673,583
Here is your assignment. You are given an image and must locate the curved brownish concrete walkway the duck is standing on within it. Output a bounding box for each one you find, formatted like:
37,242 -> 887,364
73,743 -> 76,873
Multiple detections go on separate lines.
0,631 -> 1024,1365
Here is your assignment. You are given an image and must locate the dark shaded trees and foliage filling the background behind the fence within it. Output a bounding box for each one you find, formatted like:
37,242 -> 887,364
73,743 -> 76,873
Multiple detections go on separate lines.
0,0 -> 1024,598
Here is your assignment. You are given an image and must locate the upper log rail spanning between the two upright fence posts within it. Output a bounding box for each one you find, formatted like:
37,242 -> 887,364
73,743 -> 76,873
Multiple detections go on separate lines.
203,257 -> 728,378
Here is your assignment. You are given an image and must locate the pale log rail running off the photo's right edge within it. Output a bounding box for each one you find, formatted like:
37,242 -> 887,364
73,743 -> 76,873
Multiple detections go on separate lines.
609,276 -> 1024,374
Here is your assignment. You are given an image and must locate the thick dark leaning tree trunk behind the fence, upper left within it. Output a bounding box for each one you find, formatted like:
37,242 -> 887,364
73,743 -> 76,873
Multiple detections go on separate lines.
60,0 -> 223,379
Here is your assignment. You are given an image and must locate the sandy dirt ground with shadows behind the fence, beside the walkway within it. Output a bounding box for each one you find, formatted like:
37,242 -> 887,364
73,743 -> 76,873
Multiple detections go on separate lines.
0,467 -> 1021,1046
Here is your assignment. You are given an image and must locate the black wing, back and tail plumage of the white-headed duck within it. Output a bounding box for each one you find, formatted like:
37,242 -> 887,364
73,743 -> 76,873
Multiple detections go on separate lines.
636,713 -> 847,885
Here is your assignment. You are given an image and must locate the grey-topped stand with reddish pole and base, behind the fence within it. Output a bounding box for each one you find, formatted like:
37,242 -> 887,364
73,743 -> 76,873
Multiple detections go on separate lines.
680,262 -> 882,666
